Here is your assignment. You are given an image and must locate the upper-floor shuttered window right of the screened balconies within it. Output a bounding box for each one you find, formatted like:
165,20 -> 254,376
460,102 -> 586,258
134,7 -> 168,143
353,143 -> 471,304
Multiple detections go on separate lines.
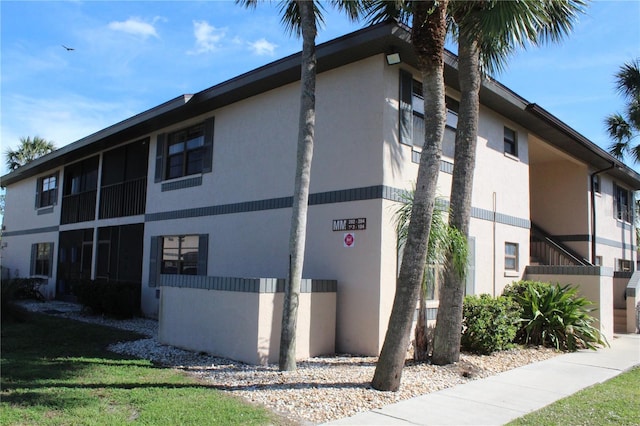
155,118 -> 213,182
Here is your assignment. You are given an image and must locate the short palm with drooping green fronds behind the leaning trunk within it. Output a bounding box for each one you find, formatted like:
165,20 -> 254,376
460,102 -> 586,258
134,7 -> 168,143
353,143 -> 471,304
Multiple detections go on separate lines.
395,190 -> 469,361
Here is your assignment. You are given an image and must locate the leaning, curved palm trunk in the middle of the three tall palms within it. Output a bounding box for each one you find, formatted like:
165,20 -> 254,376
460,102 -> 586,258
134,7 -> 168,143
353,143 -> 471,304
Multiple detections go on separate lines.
371,0 -> 447,391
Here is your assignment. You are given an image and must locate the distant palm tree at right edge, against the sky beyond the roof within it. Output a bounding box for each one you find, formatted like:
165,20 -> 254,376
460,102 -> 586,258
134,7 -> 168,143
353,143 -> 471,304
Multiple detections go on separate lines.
605,58 -> 640,163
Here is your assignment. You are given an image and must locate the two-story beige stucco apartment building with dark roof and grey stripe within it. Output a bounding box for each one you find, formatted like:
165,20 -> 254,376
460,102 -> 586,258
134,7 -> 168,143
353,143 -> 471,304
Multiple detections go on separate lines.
2,23 -> 640,362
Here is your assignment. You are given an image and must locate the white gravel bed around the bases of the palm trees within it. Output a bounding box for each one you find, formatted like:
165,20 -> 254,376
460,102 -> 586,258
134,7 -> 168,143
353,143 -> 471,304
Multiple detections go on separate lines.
23,302 -> 558,424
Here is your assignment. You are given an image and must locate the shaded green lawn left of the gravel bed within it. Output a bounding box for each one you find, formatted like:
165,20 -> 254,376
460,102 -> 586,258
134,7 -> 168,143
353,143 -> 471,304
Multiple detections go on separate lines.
0,314 -> 291,426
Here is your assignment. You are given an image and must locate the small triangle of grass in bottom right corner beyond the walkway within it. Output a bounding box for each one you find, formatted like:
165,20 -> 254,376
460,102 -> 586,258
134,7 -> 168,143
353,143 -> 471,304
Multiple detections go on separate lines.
509,367 -> 640,426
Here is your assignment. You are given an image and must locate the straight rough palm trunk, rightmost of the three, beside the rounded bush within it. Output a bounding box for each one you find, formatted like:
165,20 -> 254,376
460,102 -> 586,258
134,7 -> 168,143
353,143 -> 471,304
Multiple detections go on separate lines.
432,33 -> 481,365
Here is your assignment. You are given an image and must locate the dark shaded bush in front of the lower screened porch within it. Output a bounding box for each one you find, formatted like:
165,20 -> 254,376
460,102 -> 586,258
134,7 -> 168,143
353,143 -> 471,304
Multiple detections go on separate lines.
72,280 -> 140,318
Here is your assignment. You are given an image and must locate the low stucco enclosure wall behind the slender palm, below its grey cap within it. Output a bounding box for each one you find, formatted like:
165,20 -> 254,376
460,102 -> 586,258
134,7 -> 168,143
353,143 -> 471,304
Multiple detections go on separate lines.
158,287 -> 336,364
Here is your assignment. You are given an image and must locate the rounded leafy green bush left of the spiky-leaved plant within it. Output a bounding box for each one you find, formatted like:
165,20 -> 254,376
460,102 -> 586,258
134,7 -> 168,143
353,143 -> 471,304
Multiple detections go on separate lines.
460,294 -> 520,355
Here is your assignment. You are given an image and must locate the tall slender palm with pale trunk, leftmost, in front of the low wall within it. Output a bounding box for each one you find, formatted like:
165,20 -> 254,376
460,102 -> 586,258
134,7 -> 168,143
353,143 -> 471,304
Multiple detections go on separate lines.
236,0 -> 360,371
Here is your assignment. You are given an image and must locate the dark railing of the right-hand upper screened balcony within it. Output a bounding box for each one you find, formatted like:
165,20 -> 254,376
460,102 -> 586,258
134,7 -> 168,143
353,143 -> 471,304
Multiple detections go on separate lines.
100,177 -> 147,219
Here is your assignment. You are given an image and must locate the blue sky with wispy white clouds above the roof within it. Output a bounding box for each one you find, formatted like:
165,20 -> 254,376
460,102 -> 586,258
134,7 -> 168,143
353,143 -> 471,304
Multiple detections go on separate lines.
0,0 -> 640,175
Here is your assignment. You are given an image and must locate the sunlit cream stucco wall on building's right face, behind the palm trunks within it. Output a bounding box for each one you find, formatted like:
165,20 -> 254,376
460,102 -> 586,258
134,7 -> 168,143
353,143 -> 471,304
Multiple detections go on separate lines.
381,67 -> 530,302
